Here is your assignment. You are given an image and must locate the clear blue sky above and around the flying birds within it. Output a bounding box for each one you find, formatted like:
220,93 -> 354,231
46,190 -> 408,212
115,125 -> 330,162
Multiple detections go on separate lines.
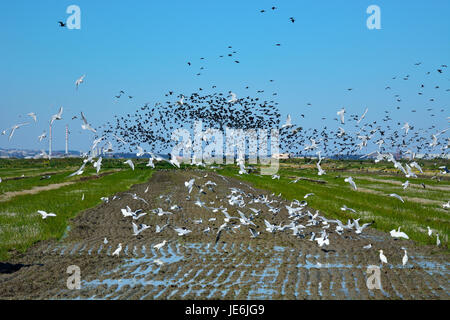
0,0 -> 450,150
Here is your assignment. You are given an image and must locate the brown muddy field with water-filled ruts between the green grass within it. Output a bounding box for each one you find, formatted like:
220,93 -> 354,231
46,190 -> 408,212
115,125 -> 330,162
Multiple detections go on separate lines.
0,170 -> 449,300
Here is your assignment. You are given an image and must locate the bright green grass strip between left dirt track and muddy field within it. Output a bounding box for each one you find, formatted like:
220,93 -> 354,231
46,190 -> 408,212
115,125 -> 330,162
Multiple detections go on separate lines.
0,168 -> 153,261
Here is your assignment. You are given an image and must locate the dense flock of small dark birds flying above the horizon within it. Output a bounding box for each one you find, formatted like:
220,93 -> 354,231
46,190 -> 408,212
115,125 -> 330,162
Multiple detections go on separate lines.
59,6 -> 450,157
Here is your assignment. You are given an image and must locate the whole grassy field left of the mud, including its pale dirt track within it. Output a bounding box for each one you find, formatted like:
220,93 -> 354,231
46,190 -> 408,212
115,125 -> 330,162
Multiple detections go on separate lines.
0,159 -> 158,261
